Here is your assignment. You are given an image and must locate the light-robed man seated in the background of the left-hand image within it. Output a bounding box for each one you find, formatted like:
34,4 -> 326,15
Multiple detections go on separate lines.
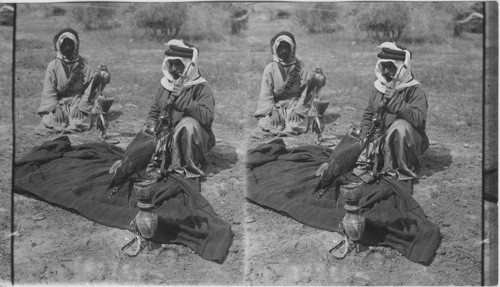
35,29 -> 106,135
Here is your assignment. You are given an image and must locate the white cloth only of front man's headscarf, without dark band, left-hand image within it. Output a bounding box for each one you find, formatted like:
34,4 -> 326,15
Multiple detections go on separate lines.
161,39 -> 207,91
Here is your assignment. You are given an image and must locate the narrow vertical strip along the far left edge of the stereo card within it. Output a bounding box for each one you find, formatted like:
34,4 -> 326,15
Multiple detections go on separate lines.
0,1 -> 15,285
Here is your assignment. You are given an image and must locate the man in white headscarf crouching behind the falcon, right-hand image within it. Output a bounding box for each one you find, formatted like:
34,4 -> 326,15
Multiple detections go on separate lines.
359,42 -> 429,180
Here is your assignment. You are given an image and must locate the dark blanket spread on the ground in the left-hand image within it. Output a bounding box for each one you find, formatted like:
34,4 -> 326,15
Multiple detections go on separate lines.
14,136 -> 233,262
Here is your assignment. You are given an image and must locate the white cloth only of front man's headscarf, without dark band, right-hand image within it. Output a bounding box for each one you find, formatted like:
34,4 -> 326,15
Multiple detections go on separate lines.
374,42 -> 420,93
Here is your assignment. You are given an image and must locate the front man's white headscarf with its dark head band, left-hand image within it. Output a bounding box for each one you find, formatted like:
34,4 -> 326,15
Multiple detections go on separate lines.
161,39 -> 207,91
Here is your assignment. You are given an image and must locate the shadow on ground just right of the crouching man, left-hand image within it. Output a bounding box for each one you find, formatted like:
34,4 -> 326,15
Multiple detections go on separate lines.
205,144 -> 238,179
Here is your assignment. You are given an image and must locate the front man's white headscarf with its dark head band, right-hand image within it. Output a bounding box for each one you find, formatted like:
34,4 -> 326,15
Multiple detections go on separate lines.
374,42 -> 420,93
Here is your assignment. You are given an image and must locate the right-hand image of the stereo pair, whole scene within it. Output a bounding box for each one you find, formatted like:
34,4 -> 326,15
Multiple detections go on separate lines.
243,2 -> 486,285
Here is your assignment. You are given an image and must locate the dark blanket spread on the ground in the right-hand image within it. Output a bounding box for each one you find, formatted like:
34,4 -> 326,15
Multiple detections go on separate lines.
247,139 -> 441,265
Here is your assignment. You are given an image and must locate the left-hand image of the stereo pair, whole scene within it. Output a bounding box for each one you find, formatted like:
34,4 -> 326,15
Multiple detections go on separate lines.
13,2 -> 248,285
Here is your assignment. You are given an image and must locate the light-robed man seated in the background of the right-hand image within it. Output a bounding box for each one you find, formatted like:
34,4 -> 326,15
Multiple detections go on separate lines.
253,32 -> 325,137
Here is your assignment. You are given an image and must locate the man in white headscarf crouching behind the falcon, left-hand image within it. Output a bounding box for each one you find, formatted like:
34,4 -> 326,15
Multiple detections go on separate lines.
144,40 -> 215,178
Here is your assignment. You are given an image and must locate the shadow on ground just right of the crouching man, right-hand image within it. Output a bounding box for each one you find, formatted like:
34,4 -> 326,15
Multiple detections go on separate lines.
420,146 -> 452,176
